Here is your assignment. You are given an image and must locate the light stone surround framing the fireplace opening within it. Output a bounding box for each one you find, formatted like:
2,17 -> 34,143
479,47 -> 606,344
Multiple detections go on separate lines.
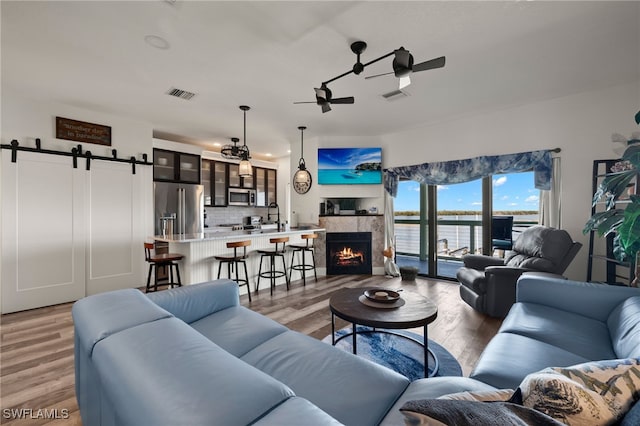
315,214 -> 384,275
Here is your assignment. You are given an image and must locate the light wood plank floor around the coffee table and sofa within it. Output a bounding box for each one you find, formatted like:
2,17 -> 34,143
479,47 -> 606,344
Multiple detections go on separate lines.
0,276 -> 501,426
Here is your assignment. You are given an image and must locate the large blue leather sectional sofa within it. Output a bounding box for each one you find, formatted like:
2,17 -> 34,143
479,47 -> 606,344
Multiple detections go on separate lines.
73,275 -> 640,426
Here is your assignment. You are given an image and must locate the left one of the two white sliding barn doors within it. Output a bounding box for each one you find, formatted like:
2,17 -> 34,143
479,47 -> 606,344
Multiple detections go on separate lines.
1,151 -> 87,313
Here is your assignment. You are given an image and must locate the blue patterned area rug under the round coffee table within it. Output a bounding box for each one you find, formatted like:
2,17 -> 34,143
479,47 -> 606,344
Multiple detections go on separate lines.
322,326 -> 462,381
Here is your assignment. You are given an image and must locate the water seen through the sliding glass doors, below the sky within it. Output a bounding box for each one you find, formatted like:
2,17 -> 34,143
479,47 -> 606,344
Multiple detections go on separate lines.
395,214 -> 538,257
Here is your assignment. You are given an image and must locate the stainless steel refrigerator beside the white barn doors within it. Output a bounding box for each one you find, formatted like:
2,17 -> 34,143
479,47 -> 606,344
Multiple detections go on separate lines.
153,182 -> 204,235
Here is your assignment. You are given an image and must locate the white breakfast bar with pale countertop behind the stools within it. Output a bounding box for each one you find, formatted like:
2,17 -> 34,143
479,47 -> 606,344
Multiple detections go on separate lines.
154,226 -> 325,293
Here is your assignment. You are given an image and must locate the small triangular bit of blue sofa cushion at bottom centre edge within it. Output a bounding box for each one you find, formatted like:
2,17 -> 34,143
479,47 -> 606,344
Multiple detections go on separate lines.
252,397 -> 342,426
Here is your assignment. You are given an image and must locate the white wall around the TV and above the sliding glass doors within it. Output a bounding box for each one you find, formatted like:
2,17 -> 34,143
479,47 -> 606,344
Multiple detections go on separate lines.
291,81 -> 640,280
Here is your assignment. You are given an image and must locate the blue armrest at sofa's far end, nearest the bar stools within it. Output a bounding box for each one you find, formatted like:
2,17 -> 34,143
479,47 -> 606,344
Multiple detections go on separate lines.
147,279 -> 240,324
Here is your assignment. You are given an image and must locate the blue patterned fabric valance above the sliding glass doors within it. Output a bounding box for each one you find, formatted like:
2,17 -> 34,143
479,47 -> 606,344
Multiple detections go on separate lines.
384,150 -> 552,197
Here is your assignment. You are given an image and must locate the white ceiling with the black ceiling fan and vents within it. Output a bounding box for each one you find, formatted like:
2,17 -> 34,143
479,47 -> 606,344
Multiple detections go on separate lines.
0,0 -> 640,157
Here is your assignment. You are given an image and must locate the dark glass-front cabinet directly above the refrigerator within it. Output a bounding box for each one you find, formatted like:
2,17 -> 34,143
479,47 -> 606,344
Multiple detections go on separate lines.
153,148 -> 200,184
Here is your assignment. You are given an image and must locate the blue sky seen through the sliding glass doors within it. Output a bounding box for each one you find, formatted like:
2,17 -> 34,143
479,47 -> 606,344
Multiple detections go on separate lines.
394,172 -> 540,212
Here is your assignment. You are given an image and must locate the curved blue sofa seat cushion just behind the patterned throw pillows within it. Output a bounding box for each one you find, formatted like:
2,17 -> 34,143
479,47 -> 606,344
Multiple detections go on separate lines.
380,377 -> 496,426
